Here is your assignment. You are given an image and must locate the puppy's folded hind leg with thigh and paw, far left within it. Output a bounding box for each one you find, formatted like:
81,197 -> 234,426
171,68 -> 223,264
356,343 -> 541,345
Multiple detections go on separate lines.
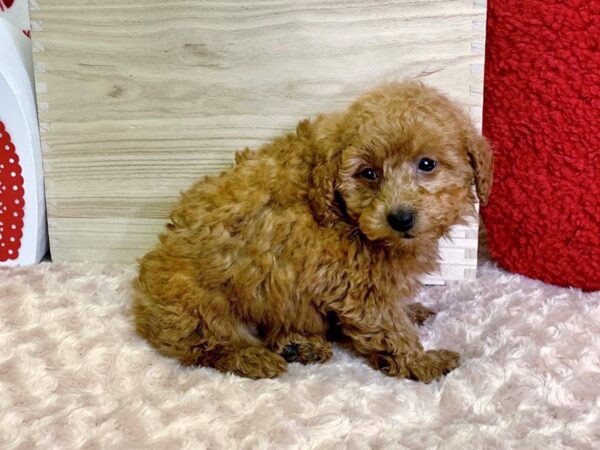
134,275 -> 287,378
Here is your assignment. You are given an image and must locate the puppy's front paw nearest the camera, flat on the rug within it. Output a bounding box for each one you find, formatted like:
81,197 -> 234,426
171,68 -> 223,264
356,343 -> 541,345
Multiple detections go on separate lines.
369,350 -> 460,383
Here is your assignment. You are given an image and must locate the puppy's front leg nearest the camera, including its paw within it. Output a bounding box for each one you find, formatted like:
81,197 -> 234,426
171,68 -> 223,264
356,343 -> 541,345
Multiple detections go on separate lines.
330,294 -> 459,383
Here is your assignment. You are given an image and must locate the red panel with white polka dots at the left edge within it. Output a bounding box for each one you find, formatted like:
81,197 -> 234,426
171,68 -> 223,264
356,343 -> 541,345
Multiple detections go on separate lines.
0,121 -> 25,261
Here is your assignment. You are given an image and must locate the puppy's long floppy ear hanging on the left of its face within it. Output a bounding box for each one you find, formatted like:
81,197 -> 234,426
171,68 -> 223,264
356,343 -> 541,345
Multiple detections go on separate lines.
308,114 -> 344,226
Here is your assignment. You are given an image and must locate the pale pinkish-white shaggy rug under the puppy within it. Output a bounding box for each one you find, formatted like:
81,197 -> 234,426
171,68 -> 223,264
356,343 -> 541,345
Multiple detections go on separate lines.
0,263 -> 600,450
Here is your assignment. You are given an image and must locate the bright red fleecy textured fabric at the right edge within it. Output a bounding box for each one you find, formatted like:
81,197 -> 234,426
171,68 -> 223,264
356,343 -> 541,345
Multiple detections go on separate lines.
482,0 -> 600,290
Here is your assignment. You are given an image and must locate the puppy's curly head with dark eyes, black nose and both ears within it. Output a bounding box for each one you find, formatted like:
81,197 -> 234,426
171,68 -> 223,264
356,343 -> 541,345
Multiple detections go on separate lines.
309,82 -> 492,245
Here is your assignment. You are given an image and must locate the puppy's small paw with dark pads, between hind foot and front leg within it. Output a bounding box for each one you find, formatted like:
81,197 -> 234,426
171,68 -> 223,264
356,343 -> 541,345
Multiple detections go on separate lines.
266,333 -> 333,364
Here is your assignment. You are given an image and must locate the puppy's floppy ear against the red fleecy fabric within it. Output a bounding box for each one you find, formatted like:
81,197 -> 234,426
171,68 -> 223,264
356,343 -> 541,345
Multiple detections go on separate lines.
465,125 -> 494,206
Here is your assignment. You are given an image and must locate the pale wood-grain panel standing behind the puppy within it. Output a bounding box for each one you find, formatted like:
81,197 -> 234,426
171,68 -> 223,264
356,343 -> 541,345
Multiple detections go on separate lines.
31,0 -> 486,278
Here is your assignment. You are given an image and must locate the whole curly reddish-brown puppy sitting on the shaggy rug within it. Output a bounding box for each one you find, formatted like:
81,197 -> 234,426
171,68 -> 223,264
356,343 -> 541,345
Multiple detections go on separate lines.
134,82 -> 492,382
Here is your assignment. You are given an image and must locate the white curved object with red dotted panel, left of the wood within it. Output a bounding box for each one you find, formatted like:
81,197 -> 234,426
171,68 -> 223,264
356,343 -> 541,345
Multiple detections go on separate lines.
0,18 -> 48,266
